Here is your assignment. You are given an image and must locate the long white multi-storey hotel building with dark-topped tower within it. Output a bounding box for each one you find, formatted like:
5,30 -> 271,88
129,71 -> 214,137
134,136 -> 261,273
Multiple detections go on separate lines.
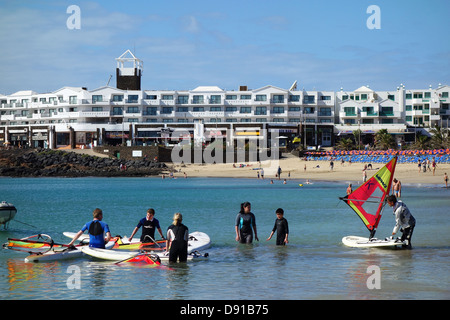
0,50 -> 450,148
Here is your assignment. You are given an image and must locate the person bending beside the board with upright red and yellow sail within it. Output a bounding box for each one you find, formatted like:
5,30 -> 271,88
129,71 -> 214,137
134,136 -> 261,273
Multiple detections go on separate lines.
387,195 -> 416,249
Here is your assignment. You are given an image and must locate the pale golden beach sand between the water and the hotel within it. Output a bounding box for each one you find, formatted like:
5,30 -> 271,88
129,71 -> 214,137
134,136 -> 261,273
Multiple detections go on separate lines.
167,155 -> 450,186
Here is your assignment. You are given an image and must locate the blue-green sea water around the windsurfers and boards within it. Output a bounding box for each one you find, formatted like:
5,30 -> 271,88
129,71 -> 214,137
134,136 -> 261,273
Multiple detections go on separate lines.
0,178 -> 450,300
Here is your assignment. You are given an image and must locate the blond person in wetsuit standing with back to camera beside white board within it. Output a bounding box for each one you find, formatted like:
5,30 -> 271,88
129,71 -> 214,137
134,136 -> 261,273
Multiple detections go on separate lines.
166,213 -> 189,262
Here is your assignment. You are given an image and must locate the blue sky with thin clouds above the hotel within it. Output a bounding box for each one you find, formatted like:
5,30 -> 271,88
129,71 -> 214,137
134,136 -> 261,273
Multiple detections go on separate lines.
0,0 -> 450,95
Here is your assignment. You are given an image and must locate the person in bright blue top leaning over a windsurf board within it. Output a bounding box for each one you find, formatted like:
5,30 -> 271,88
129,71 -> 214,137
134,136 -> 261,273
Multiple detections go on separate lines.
68,208 -> 111,249
